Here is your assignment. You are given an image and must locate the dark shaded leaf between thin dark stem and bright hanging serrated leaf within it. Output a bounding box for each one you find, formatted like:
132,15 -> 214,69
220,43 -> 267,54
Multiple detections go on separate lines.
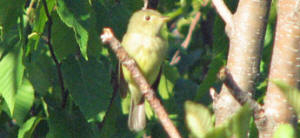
51,14 -> 78,61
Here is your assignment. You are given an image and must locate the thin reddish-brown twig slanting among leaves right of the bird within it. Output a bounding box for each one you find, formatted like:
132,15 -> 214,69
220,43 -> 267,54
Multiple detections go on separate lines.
170,11 -> 201,65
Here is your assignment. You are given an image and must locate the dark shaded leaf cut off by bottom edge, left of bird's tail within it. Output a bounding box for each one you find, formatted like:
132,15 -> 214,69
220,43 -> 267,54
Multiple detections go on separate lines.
47,109 -> 95,138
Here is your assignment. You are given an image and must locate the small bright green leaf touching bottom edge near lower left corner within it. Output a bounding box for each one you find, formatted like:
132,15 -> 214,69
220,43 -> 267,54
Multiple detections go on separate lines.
18,116 -> 42,138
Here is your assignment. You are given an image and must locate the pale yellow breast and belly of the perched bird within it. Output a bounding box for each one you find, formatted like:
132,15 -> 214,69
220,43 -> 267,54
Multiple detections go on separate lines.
122,33 -> 168,83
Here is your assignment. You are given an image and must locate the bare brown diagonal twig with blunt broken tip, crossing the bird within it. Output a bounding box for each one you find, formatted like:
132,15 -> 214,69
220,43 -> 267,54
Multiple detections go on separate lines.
101,28 -> 181,138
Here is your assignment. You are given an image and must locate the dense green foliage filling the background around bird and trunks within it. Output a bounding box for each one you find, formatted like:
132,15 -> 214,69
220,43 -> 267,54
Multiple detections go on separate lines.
0,0 -> 299,138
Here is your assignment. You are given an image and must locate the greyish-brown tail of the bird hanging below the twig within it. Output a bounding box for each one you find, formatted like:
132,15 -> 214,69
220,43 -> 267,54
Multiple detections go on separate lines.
128,98 -> 146,132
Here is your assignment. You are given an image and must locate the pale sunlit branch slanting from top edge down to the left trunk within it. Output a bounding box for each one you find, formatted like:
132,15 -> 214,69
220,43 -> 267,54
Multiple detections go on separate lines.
212,0 -> 233,28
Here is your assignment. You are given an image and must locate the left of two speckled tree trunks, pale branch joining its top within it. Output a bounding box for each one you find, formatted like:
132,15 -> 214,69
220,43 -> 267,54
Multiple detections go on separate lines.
213,0 -> 271,126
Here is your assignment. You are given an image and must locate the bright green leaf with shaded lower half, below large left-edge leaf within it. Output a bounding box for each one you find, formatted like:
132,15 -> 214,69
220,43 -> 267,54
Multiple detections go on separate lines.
13,79 -> 34,125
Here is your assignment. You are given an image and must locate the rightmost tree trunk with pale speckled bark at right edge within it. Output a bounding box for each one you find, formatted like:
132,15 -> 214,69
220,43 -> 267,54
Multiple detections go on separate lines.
261,0 -> 300,137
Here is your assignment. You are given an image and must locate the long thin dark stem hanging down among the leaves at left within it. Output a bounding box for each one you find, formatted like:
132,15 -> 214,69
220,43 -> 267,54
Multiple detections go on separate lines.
42,0 -> 68,108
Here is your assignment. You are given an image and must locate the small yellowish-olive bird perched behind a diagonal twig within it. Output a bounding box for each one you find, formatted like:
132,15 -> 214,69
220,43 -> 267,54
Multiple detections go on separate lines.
121,9 -> 169,132
